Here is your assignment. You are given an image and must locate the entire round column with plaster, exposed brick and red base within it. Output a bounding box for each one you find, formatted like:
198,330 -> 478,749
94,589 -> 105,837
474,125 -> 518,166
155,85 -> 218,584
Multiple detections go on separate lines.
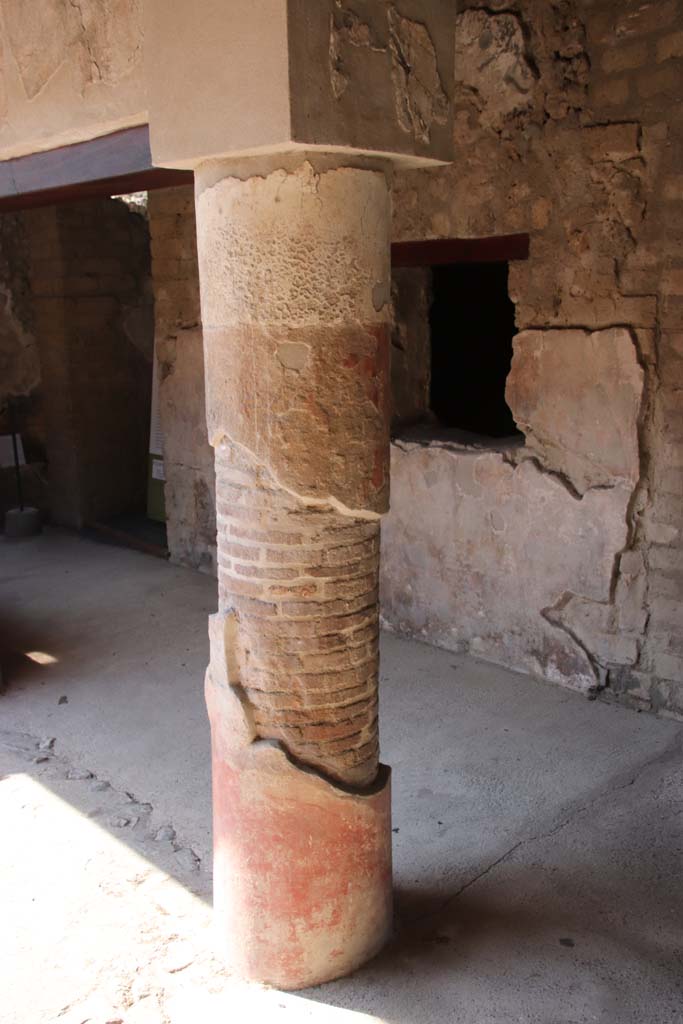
196,160 -> 391,988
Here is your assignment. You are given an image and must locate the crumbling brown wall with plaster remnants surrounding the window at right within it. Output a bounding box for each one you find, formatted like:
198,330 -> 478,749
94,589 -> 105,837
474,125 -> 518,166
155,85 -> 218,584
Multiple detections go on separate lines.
382,0 -> 683,715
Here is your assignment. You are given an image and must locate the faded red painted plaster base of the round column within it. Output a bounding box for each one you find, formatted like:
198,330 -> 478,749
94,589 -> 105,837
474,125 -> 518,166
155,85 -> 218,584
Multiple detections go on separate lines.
207,673 -> 392,989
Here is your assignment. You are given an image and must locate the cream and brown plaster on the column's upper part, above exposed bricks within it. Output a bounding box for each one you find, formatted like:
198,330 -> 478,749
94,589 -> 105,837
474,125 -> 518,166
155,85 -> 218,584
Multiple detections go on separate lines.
198,162 -> 389,516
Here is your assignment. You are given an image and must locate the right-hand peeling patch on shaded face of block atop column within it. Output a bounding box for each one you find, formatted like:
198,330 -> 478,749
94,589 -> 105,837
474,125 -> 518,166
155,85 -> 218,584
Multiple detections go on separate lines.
389,7 -> 449,142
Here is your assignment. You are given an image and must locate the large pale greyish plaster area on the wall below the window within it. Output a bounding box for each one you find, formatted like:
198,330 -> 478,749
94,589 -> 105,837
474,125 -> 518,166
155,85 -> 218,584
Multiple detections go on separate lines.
381,441 -> 637,690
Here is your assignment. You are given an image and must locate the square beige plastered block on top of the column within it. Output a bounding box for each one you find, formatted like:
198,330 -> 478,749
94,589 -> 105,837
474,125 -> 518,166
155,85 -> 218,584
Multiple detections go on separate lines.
145,0 -> 455,168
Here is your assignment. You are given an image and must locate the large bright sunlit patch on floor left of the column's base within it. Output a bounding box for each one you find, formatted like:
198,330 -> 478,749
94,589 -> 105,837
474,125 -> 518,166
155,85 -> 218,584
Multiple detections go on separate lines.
0,764 -> 385,1024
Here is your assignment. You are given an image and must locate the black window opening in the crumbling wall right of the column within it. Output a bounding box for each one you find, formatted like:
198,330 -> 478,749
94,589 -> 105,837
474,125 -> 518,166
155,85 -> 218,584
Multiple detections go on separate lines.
430,263 -> 520,437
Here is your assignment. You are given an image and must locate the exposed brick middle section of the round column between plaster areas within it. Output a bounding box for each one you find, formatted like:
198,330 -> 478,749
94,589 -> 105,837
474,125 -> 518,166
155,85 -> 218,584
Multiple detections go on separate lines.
216,444 -> 379,786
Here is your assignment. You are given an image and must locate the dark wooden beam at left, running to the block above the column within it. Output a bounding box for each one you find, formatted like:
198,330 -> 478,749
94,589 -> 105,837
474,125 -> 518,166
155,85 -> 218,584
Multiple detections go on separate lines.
0,125 -> 193,213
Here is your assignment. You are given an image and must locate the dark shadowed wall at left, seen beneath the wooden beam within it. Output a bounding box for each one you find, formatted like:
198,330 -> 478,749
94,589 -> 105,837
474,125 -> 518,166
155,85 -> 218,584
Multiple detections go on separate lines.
23,200 -> 153,526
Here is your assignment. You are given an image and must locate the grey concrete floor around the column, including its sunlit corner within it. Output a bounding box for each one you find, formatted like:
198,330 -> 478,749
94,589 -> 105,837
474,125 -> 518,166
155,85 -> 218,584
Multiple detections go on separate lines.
0,531 -> 683,1024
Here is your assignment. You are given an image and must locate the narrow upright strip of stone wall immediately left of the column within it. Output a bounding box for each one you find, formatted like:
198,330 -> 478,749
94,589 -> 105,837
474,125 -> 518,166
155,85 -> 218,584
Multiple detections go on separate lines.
148,186 -> 216,572
